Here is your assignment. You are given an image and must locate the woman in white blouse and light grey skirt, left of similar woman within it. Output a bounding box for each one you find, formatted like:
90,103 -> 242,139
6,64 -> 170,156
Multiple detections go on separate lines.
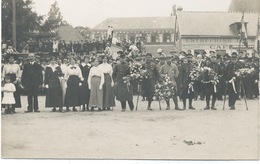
88,59 -> 104,111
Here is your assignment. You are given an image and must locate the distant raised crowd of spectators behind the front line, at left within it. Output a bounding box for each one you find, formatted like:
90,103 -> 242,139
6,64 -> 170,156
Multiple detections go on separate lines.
2,38 -> 143,57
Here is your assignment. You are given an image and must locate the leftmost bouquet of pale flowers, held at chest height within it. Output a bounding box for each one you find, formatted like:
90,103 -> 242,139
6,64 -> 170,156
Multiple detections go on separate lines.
130,62 -> 144,82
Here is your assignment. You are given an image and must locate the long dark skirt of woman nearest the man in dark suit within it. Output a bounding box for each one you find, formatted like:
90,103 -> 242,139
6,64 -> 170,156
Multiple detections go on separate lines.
45,77 -> 62,107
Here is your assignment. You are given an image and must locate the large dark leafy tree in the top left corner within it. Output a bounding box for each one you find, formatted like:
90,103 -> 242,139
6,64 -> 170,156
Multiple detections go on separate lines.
2,0 -> 43,48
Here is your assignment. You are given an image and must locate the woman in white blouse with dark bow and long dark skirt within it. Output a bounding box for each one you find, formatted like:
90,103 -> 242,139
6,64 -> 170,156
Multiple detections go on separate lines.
65,57 -> 83,111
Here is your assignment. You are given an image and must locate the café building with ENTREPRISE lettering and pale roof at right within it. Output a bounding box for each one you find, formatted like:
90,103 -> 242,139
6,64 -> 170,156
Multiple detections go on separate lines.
177,11 -> 258,54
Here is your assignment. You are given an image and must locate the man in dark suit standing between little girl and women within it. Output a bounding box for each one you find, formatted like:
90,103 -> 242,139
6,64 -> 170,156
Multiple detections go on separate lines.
21,54 -> 43,113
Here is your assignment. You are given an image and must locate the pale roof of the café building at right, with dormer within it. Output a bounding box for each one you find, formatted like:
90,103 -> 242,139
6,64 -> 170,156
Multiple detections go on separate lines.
178,11 -> 258,36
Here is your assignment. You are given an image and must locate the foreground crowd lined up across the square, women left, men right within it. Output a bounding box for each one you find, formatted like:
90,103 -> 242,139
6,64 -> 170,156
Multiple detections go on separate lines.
2,47 -> 259,114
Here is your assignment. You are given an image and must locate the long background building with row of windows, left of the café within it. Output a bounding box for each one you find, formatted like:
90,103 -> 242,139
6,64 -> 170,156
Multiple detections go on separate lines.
92,16 -> 175,53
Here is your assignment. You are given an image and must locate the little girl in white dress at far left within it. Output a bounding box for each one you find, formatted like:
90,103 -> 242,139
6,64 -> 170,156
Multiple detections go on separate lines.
2,76 -> 16,114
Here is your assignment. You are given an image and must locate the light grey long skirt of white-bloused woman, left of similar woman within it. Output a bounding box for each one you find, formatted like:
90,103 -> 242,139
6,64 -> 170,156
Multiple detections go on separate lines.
89,76 -> 103,108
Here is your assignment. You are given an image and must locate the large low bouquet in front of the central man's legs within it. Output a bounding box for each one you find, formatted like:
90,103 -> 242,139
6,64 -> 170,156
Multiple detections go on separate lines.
155,75 -> 177,100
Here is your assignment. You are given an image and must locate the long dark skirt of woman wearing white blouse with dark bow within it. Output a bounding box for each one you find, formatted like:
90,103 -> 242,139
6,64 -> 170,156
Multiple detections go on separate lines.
65,75 -> 80,107
